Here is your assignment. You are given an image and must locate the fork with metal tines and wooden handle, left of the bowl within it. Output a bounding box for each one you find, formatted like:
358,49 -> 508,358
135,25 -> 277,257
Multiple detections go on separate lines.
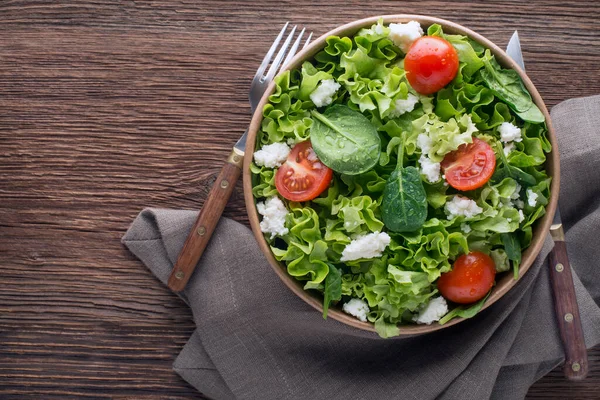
168,22 -> 312,292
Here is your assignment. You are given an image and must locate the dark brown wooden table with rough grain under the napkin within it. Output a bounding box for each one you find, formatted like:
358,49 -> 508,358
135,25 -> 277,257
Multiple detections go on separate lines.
0,0 -> 600,399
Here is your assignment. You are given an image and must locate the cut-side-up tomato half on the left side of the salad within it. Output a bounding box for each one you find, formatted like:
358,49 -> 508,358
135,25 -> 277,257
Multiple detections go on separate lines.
275,140 -> 333,201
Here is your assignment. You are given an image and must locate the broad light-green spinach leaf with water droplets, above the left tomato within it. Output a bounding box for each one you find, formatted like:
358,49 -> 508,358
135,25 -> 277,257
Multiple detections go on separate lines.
310,104 -> 381,175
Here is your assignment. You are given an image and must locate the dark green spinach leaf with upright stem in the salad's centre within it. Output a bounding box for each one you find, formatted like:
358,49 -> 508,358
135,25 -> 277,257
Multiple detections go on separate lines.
381,137 -> 427,232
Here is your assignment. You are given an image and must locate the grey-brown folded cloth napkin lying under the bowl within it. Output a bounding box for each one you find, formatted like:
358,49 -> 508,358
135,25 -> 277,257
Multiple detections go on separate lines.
123,96 -> 600,400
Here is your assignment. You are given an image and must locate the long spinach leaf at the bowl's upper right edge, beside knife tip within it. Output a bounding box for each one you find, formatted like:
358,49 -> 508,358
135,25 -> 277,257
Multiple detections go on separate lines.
480,52 -> 545,124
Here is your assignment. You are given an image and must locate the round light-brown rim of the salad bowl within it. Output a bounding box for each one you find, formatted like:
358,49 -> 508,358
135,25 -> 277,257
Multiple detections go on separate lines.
243,14 -> 560,337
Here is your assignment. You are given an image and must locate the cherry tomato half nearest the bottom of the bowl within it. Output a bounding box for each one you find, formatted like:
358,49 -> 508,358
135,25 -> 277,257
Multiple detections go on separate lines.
438,251 -> 496,304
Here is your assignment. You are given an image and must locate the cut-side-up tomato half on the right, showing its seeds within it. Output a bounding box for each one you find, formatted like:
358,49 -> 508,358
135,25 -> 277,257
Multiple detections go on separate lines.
440,138 -> 496,190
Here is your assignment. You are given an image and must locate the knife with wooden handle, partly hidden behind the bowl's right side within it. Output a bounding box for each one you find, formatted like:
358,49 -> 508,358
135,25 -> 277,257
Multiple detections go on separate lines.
506,31 -> 588,380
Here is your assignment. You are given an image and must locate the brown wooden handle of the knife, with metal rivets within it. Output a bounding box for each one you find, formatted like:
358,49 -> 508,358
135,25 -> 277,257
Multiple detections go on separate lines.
548,240 -> 588,380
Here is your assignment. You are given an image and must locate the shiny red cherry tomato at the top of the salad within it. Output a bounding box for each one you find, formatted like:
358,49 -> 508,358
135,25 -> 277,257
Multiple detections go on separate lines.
404,36 -> 458,94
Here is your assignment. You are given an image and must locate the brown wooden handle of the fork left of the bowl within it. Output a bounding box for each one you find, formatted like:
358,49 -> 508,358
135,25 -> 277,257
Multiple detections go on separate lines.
168,150 -> 244,292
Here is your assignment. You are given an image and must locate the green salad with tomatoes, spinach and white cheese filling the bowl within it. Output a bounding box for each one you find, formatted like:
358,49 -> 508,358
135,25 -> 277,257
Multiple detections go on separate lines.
251,20 -> 551,337
